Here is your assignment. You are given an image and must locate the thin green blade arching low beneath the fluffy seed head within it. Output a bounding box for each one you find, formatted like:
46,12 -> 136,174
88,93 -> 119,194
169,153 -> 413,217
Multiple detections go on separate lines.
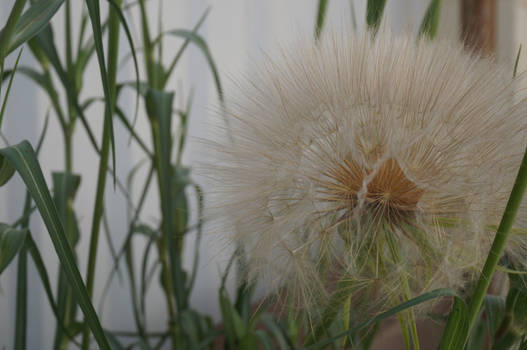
303,288 -> 458,350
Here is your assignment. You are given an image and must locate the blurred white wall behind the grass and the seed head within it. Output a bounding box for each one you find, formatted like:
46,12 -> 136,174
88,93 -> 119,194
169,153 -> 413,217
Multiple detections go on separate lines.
0,0 -> 516,349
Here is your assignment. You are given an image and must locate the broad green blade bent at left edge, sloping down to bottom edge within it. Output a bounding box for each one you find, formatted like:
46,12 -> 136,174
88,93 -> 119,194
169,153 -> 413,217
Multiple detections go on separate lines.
0,141 -> 110,350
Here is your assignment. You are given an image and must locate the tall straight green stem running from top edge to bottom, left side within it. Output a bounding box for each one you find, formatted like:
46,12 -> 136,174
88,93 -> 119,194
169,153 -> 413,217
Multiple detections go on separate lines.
82,0 -> 121,350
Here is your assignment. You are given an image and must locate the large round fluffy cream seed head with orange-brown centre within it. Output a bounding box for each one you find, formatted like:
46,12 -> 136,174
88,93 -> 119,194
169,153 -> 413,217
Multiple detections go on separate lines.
204,31 -> 527,318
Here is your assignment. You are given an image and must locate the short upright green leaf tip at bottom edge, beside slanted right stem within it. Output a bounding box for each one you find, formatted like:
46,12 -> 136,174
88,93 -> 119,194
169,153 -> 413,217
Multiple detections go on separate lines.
439,298 -> 469,350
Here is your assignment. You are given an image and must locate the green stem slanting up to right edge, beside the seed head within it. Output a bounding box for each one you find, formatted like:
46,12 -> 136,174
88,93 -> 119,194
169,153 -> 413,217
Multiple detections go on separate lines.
465,149 -> 527,334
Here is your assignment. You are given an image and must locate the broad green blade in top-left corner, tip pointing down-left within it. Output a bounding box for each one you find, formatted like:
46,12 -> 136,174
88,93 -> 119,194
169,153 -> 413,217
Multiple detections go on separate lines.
4,0 -> 64,53
